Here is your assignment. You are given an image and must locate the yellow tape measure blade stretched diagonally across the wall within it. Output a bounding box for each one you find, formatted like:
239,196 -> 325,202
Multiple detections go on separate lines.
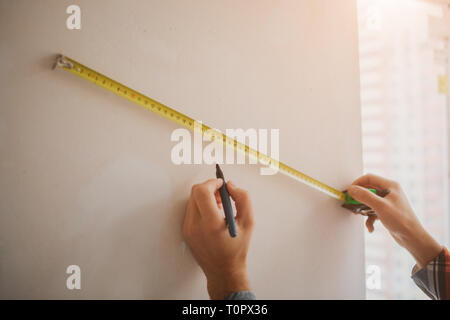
55,55 -> 346,201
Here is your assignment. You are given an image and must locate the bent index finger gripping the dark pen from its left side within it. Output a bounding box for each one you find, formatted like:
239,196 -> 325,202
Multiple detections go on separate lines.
192,179 -> 223,221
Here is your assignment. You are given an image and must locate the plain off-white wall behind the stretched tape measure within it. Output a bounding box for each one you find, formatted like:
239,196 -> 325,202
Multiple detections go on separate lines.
0,0 -> 364,299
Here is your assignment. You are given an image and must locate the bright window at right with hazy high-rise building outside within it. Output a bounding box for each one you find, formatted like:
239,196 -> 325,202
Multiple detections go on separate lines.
358,0 -> 450,299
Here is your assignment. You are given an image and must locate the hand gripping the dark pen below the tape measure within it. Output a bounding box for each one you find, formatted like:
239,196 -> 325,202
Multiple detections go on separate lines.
182,179 -> 254,299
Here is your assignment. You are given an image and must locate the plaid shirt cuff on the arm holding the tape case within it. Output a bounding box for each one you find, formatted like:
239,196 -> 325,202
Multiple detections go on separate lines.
411,248 -> 450,300
